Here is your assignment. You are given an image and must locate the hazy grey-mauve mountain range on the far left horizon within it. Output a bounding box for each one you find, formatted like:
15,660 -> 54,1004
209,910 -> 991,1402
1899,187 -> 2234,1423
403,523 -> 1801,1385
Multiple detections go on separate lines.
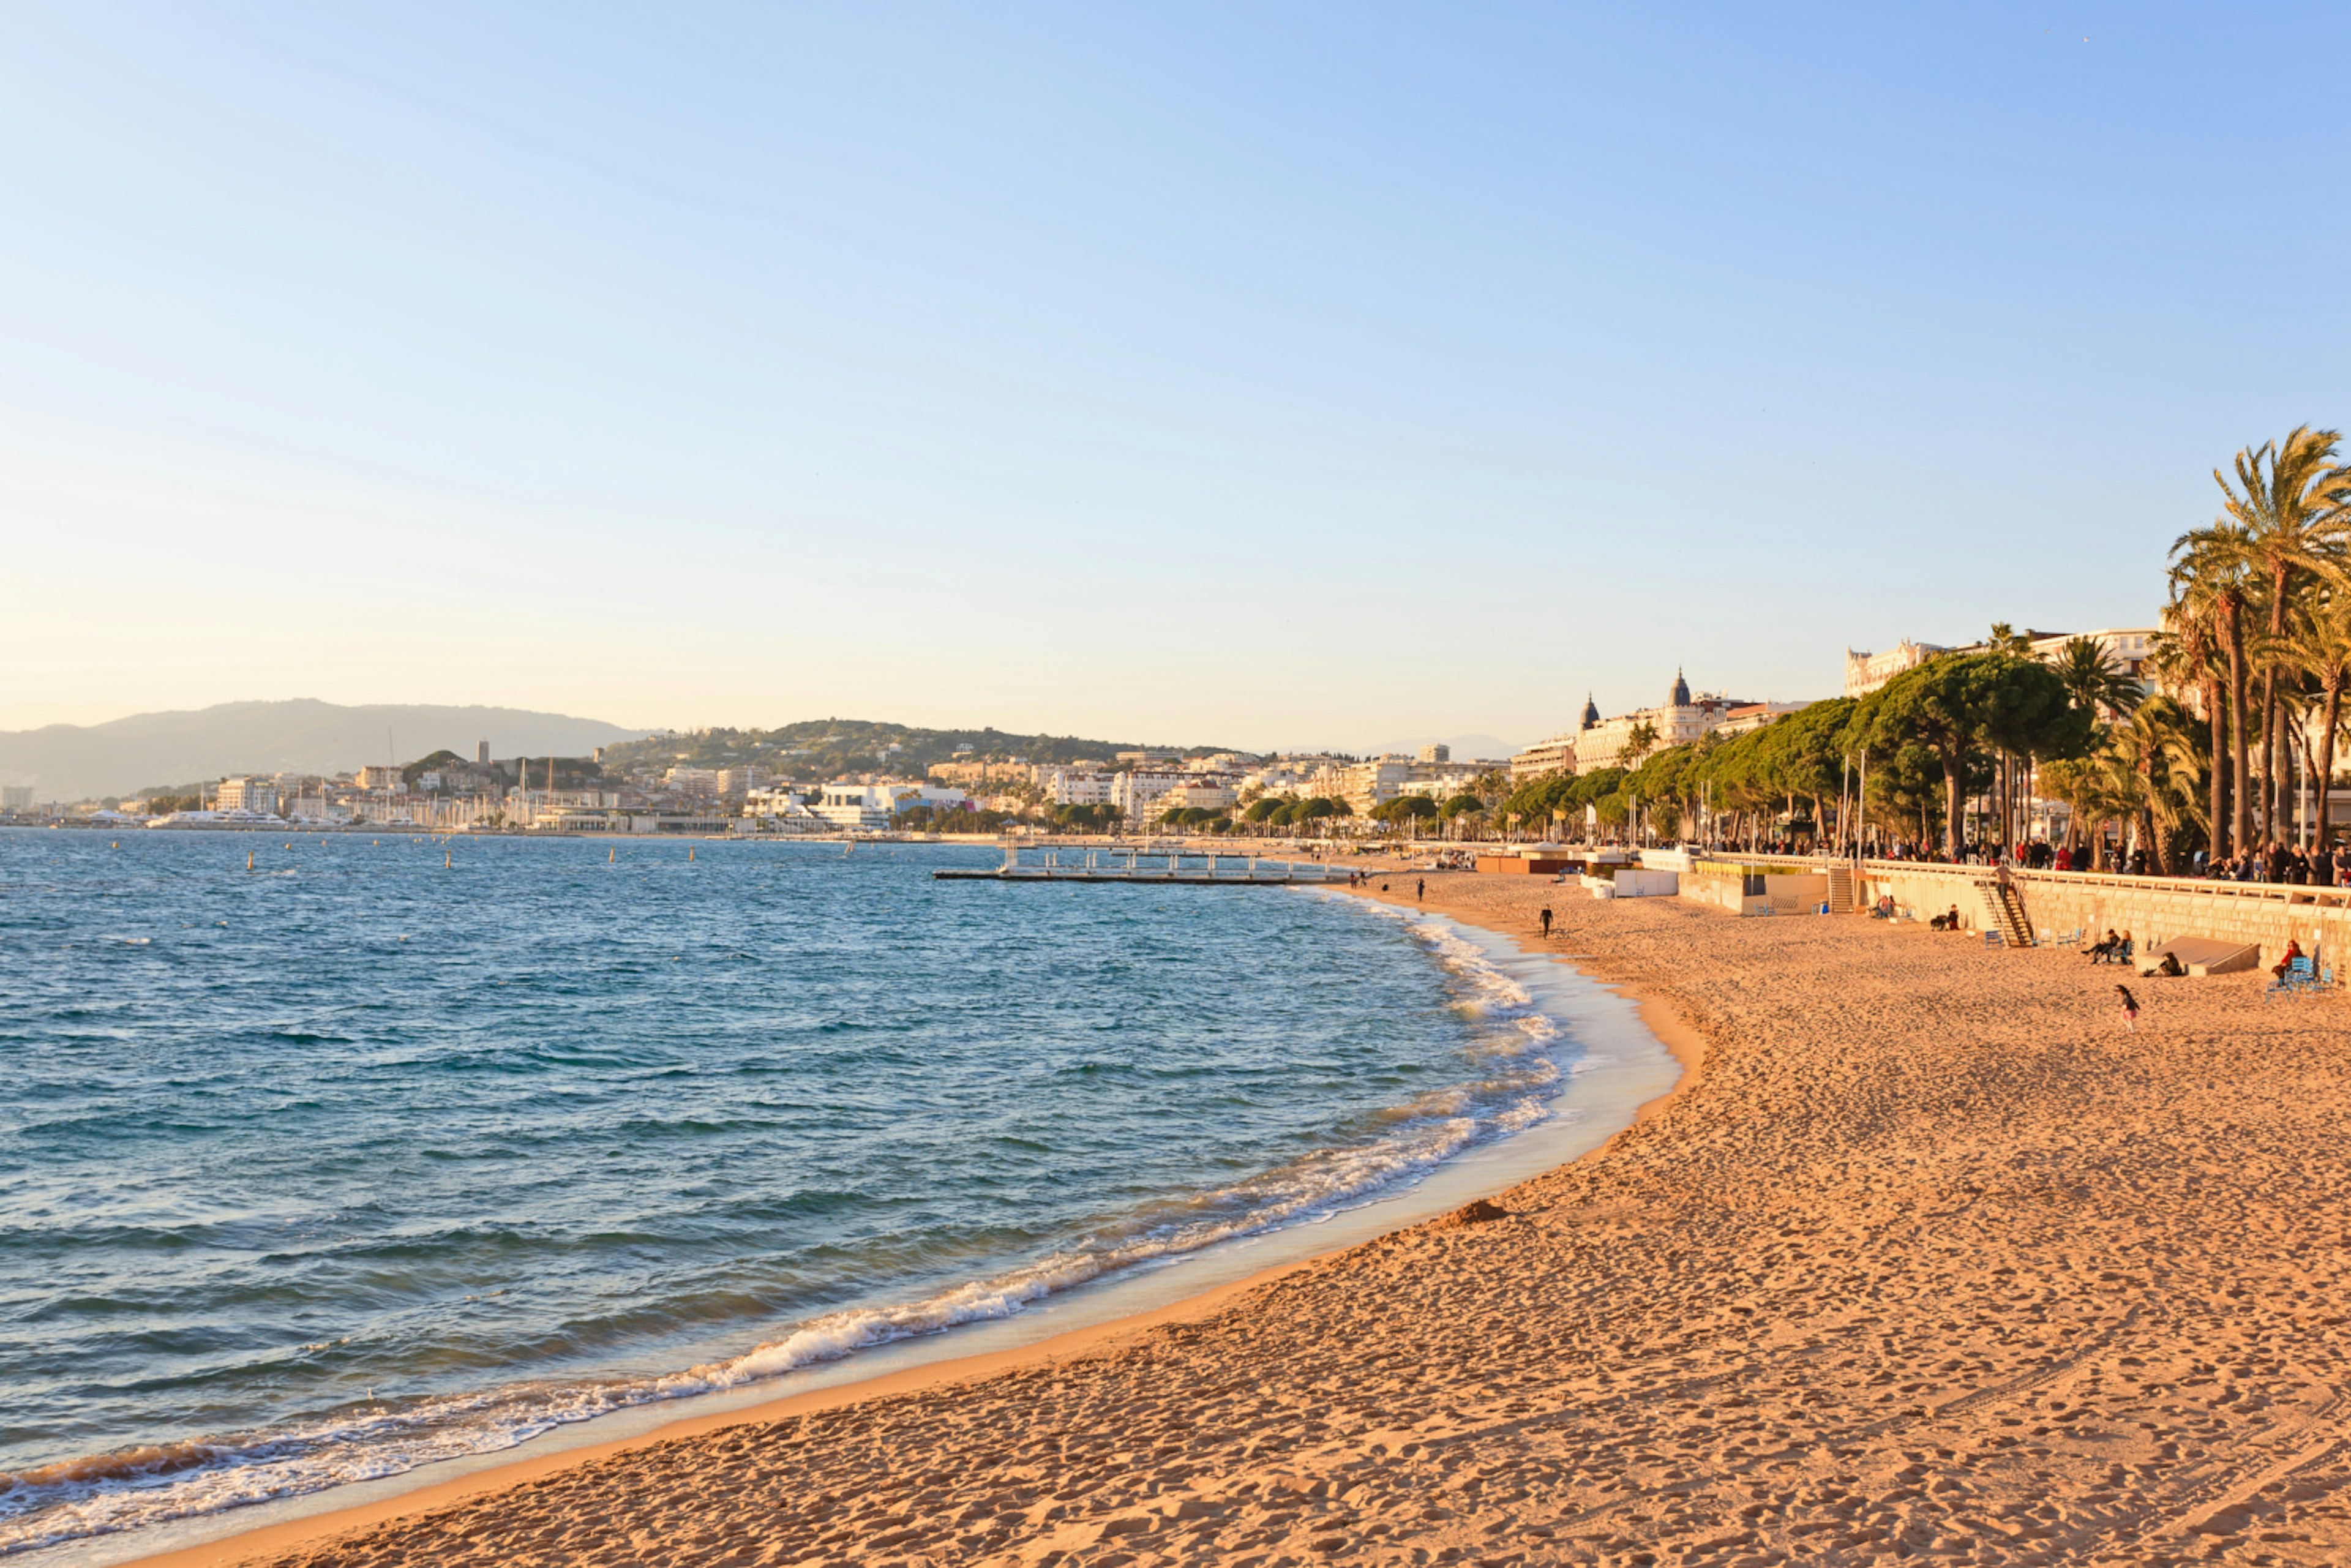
0,698 -> 651,799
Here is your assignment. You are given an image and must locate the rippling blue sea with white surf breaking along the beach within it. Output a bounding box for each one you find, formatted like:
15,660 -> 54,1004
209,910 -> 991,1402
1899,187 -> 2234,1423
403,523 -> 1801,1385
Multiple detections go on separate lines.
0,830 -> 1671,1563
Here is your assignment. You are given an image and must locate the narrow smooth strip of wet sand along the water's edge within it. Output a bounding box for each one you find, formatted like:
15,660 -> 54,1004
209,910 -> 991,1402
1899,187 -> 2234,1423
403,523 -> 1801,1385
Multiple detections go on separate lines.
91,884 -> 1704,1568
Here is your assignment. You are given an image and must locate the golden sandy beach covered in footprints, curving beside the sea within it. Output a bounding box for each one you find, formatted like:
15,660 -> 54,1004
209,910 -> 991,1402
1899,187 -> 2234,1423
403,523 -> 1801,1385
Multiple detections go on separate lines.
129,872 -> 2351,1568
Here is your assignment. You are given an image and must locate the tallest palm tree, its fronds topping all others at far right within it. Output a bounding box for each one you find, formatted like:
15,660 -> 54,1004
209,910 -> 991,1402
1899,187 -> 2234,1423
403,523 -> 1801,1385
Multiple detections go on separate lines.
2212,426 -> 2351,837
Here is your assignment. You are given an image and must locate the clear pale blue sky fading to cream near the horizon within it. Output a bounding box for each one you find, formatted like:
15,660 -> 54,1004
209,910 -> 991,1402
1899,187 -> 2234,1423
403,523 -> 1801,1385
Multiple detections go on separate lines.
0,2 -> 2351,748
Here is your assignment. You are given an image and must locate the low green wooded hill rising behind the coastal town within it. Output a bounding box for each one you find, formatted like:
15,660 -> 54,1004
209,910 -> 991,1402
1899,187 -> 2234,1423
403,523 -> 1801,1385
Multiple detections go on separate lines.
604,719 -> 1229,778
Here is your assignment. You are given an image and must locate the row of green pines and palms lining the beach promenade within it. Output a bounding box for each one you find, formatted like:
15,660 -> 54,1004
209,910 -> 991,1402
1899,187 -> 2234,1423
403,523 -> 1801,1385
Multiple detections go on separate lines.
1500,428 -> 2351,882
